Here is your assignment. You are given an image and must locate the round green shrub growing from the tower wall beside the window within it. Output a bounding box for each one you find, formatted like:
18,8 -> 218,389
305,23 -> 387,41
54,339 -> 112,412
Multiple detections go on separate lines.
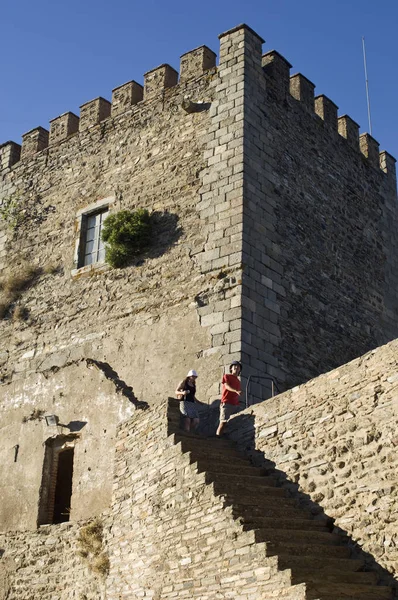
102,209 -> 151,268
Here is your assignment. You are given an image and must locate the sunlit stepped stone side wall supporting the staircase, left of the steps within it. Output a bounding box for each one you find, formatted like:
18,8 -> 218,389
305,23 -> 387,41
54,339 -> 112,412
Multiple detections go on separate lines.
103,403 -> 305,600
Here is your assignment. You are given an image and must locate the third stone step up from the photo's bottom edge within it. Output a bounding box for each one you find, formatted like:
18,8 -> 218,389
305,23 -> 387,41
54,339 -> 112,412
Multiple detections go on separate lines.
278,549 -> 365,576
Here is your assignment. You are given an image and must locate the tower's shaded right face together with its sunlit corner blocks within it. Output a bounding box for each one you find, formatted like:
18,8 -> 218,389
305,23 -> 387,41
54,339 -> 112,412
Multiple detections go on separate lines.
197,25 -> 398,408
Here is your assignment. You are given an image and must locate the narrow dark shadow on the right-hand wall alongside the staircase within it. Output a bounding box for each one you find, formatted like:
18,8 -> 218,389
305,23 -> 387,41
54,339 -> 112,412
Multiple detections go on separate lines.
227,414 -> 398,598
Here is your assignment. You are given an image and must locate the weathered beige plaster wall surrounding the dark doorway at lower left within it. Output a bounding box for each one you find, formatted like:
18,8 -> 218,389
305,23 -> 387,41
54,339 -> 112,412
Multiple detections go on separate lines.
0,361 -> 135,531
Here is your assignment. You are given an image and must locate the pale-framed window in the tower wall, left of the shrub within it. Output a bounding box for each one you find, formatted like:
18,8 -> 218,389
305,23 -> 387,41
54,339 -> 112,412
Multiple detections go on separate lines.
72,197 -> 114,275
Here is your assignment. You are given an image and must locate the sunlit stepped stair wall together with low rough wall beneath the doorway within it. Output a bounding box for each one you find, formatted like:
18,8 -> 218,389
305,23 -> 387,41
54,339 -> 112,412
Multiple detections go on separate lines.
0,401 -> 305,600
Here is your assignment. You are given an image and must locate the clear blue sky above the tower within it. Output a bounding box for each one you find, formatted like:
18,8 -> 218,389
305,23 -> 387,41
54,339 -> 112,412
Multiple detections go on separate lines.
0,0 -> 398,158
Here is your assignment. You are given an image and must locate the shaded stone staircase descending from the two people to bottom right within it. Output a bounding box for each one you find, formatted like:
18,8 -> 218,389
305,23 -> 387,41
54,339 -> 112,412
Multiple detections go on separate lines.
174,432 -> 393,600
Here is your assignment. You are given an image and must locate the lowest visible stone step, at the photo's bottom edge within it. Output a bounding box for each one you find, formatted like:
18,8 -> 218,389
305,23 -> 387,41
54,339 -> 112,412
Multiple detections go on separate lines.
306,582 -> 393,600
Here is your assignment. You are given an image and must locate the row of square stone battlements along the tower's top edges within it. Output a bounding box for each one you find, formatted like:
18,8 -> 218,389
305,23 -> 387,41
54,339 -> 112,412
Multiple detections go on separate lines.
0,25 -> 396,185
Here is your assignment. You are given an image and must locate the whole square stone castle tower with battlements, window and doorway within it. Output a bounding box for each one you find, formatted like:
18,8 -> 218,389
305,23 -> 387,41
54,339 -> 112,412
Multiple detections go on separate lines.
0,25 -> 398,596
